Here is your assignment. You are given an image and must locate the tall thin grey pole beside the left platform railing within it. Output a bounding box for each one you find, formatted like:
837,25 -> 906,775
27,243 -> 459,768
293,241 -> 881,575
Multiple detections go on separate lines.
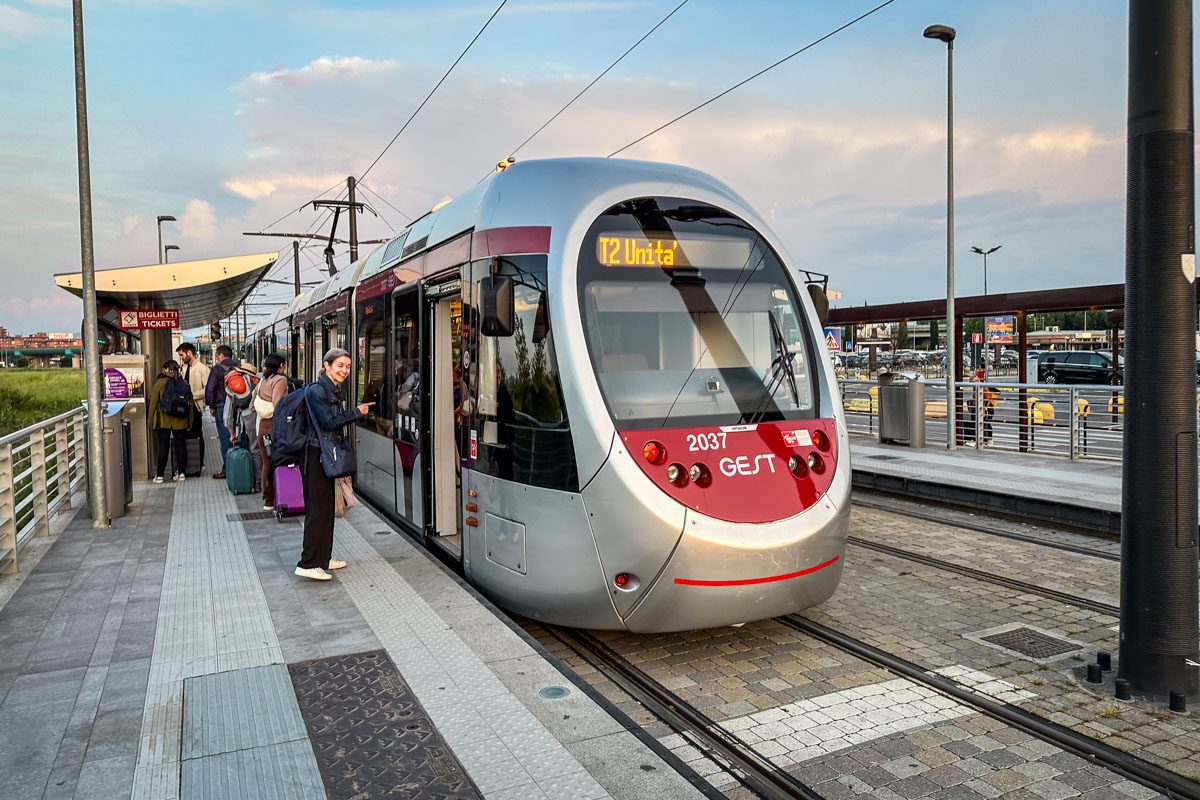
71,0 -> 109,528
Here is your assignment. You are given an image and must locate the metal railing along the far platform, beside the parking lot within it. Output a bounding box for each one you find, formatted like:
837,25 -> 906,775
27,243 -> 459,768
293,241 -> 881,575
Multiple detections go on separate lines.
838,380 -> 1128,461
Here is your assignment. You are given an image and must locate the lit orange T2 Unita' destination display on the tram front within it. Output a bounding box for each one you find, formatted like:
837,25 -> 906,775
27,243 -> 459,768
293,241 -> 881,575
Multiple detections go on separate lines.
596,233 -> 750,270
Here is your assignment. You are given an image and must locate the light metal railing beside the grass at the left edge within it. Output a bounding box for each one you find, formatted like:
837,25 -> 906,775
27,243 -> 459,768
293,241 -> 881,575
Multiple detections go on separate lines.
0,408 -> 86,576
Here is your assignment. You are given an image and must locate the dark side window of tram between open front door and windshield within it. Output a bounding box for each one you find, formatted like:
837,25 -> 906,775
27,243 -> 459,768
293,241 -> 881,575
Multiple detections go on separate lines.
463,255 -> 580,492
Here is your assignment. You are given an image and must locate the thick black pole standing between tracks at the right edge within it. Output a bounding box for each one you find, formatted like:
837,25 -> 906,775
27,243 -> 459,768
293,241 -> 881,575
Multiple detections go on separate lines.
1120,0 -> 1200,697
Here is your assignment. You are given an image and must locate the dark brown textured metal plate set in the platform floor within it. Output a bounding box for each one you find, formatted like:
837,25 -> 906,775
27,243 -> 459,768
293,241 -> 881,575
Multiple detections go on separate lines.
288,650 -> 481,800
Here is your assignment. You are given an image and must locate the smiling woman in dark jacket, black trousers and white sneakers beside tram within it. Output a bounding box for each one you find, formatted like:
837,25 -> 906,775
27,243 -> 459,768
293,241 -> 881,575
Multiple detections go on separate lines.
296,348 -> 374,581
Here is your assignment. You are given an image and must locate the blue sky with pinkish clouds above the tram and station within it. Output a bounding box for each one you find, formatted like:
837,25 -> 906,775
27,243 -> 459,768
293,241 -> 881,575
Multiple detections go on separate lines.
0,0 -> 1142,332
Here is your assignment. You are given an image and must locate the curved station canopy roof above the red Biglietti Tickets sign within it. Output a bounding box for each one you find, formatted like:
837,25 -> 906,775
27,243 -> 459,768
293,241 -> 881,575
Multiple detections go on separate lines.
54,253 -> 278,330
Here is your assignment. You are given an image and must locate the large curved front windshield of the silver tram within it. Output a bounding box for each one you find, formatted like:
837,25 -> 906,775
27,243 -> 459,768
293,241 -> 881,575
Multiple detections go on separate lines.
580,198 -> 816,429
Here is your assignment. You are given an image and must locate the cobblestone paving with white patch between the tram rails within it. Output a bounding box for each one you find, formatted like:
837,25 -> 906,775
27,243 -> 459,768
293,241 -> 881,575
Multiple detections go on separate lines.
520,509 -> 1200,799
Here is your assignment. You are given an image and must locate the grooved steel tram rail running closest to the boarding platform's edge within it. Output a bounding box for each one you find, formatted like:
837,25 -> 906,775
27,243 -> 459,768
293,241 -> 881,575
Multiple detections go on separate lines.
544,625 -> 824,800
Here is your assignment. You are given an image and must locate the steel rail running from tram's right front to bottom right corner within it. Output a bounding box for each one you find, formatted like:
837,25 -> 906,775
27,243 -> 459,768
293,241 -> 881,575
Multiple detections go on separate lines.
776,614 -> 1200,800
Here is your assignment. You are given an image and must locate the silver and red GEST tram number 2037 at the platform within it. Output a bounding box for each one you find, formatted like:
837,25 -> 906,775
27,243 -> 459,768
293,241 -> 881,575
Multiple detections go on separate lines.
243,158 -> 851,632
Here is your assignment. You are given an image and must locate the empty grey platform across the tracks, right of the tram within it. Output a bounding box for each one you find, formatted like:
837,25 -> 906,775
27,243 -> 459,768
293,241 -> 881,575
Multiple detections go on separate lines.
850,434 -> 1121,535
